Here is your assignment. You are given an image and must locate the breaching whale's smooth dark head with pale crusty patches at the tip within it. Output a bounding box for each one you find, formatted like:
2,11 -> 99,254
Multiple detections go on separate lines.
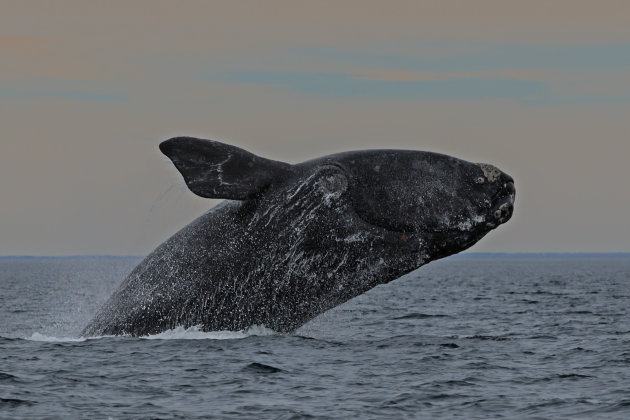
316,150 -> 515,260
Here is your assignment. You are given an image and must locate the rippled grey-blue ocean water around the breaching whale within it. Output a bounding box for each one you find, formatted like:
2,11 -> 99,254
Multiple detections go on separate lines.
0,255 -> 630,419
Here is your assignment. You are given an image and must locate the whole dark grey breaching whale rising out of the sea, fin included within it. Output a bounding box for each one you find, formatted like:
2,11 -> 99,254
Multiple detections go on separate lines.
82,137 -> 515,336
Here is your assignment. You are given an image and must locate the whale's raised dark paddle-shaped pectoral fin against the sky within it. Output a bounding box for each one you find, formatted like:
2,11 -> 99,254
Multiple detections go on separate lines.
160,137 -> 291,200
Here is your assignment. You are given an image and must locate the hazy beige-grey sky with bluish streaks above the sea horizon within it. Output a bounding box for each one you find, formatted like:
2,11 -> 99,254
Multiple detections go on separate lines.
0,0 -> 630,255
